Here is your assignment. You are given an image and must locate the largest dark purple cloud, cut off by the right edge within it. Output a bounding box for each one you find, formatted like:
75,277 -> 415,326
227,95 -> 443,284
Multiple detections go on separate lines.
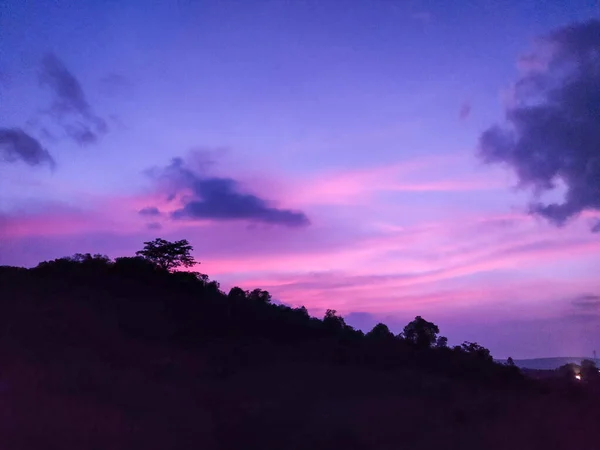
479,20 -> 600,231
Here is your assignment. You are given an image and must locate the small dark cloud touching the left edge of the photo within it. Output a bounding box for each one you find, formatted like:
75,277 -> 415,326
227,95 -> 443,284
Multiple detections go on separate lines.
0,128 -> 55,168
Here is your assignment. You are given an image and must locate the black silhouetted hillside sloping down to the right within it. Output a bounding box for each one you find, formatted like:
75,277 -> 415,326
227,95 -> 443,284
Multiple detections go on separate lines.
0,258 -> 600,450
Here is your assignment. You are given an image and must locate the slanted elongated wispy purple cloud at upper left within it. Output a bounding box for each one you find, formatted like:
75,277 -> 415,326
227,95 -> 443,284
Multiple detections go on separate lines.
40,54 -> 108,145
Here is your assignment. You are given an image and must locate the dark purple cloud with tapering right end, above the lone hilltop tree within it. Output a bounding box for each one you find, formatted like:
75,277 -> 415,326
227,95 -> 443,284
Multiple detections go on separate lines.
151,158 -> 309,226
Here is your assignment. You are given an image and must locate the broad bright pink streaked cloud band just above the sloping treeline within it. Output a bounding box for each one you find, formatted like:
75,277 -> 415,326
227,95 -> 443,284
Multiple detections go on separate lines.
223,212 -> 600,311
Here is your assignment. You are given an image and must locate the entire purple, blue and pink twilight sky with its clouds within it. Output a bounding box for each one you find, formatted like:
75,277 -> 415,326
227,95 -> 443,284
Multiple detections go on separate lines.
0,0 -> 600,358
